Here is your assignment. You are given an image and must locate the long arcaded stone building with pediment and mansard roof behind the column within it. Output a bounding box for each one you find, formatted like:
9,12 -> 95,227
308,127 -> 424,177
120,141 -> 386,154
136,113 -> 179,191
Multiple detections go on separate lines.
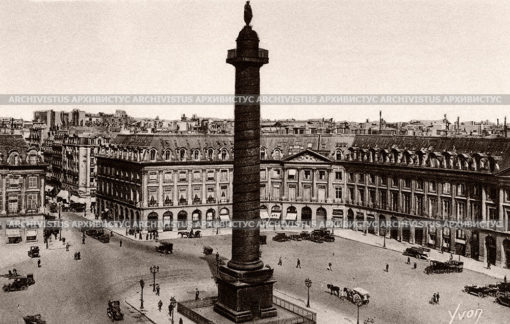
97,135 -> 510,267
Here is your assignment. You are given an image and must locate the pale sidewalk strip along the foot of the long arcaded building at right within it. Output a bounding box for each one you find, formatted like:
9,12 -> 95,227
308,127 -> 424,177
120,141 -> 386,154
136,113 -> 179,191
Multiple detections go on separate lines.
335,228 -> 510,280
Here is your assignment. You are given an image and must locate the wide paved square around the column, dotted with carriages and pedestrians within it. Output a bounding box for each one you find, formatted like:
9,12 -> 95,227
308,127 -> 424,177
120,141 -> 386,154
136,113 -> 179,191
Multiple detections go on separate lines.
0,214 -> 510,323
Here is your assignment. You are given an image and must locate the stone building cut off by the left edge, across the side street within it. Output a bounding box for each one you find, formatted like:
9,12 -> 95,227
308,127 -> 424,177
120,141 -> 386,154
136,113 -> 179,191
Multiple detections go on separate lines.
0,134 -> 46,244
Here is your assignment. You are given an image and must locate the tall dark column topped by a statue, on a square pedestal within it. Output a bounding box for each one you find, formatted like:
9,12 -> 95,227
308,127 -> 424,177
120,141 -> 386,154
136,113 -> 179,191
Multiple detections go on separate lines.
214,1 -> 277,323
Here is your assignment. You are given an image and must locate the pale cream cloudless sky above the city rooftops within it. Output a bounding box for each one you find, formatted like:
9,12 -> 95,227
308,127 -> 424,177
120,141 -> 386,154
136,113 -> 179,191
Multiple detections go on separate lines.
0,0 -> 510,121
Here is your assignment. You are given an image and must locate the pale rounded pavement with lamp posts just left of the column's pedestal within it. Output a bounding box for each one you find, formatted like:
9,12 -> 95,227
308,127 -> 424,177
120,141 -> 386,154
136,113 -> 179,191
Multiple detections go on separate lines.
125,280 -> 217,324
